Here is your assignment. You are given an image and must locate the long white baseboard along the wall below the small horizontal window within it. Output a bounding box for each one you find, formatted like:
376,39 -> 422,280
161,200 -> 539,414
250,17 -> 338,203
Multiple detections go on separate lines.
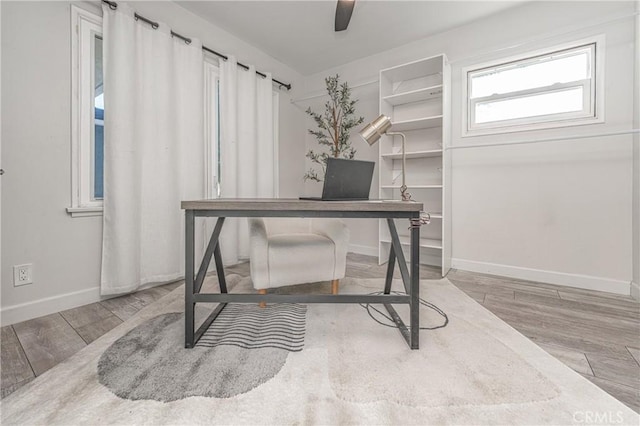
451,258 -> 631,296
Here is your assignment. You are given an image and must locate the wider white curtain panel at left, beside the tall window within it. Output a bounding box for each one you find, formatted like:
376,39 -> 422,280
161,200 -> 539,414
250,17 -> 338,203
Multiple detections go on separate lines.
101,3 -> 204,295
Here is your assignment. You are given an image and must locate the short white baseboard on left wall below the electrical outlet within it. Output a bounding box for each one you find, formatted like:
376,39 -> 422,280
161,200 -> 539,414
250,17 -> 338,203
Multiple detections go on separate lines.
0,287 -> 101,326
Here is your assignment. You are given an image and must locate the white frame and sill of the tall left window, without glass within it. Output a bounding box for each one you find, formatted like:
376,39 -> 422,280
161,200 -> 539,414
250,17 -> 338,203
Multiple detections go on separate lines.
67,5 -> 103,217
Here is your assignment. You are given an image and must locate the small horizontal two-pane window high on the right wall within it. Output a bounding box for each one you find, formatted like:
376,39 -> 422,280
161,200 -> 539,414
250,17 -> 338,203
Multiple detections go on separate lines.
463,38 -> 604,136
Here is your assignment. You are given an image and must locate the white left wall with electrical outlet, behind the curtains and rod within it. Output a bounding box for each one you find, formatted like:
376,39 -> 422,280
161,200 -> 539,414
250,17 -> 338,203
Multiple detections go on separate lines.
0,1 -> 304,324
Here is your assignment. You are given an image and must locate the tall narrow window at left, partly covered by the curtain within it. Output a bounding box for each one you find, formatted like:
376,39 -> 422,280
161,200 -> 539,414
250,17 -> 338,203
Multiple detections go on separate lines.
67,6 -> 104,216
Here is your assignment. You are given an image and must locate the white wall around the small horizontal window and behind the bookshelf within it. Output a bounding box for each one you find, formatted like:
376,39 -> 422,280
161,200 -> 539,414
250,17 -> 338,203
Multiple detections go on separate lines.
304,2 -> 634,294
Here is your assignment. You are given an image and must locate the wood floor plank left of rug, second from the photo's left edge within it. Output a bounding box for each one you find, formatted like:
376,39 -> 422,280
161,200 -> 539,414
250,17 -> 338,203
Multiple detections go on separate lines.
13,314 -> 87,376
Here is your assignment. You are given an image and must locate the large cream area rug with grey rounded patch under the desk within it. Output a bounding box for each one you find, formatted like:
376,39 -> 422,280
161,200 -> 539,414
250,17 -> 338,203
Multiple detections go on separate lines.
0,275 -> 640,425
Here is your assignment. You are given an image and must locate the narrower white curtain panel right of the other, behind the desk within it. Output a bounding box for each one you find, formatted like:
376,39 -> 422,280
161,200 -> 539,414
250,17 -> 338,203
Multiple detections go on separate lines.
220,56 -> 276,264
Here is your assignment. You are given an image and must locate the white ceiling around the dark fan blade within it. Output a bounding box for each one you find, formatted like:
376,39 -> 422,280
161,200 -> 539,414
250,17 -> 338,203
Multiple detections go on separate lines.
176,0 -> 523,75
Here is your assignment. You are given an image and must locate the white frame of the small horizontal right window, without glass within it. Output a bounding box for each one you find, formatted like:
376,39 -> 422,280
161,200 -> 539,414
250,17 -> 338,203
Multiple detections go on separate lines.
462,35 -> 605,137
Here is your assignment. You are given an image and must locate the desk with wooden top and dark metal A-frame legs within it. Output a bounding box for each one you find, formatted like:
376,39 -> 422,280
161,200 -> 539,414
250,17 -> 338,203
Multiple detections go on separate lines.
181,198 -> 423,349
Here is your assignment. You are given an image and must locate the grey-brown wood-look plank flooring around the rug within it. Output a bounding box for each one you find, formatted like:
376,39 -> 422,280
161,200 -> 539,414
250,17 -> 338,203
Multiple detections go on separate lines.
0,253 -> 640,412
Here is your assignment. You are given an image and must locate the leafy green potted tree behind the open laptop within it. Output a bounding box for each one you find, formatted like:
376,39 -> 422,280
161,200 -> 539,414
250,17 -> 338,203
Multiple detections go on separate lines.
304,74 -> 364,182
